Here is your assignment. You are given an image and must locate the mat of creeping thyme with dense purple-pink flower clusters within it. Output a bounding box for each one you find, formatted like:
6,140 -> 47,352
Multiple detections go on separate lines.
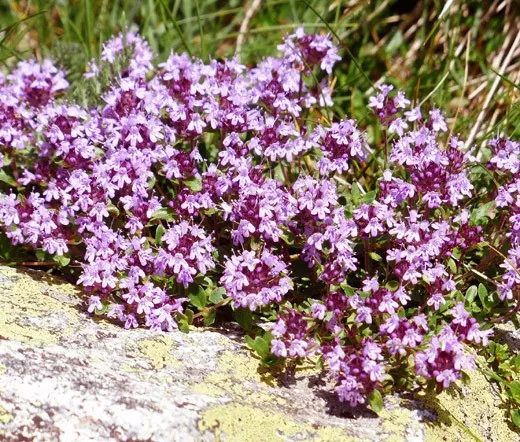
0,30 -> 520,414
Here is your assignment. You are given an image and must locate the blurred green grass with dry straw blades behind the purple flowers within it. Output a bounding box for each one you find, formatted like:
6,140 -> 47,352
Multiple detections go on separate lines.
0,0 -> 520,141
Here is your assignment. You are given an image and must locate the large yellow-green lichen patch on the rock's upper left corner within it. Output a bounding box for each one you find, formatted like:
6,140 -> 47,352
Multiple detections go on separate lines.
0,267 -> 79,345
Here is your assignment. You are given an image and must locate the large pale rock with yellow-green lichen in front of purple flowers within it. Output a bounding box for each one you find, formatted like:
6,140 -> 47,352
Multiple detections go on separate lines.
0,267 -> 517,442
